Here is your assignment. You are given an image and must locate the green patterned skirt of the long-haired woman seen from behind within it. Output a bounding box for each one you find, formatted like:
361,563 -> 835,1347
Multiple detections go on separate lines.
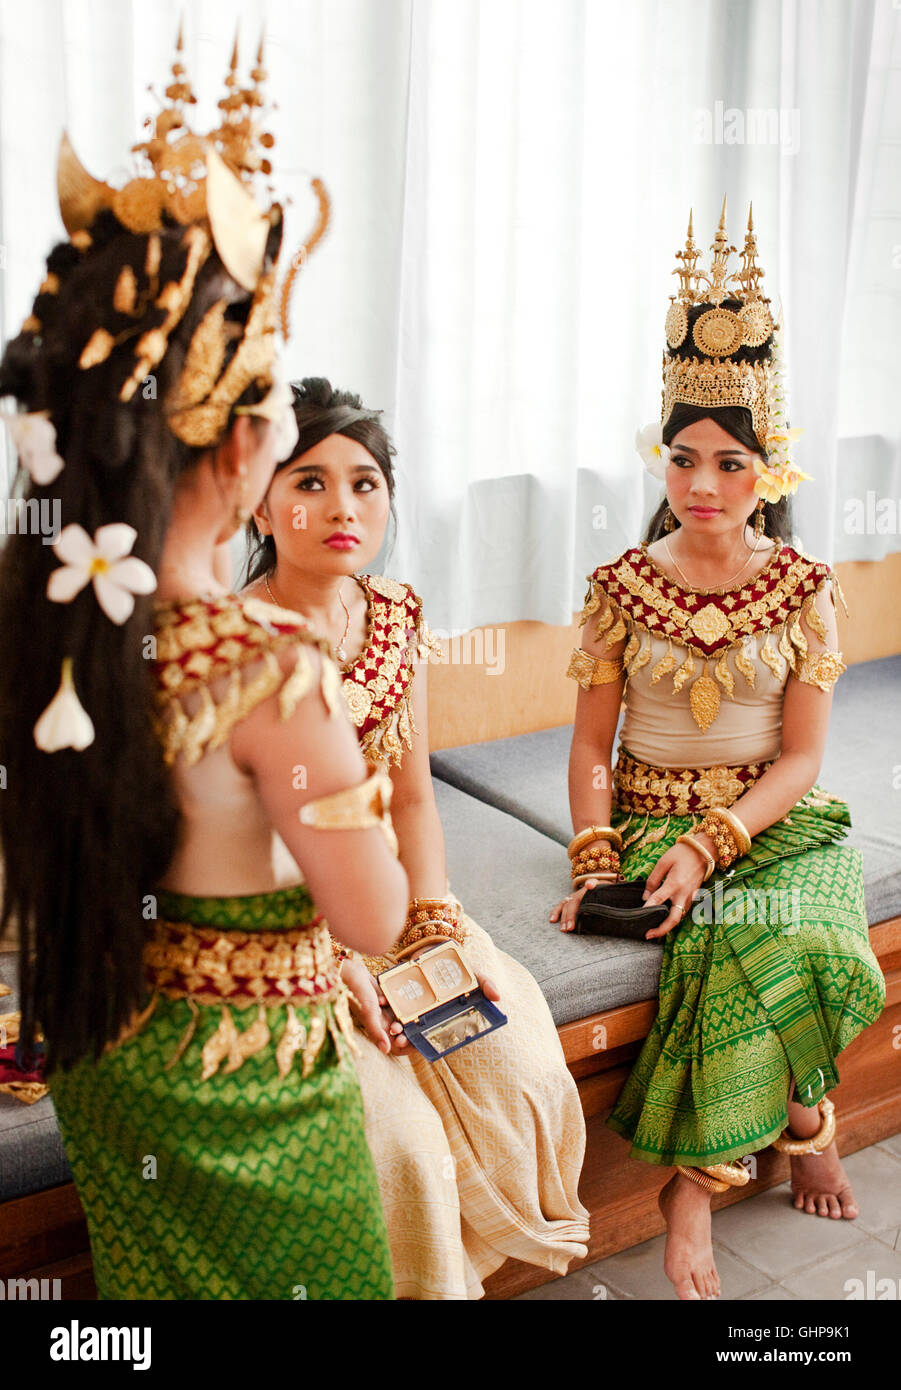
51,888 -> 393,1300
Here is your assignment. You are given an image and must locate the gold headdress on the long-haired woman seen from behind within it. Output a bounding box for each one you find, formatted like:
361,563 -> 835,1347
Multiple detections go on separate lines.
51,28 -> 330,448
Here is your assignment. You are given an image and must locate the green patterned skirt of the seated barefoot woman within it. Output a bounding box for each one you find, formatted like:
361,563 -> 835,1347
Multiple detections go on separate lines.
608,787 -> 886,1166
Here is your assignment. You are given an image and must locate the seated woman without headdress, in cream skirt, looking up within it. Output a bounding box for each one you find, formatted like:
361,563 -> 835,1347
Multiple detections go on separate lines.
245,379 -> 588,1298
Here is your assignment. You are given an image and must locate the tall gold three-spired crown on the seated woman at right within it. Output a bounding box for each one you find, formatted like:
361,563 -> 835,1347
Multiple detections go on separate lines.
660,199 -> 806,502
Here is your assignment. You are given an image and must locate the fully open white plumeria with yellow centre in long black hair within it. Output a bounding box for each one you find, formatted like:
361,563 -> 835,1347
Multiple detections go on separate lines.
47,521 -> 156,624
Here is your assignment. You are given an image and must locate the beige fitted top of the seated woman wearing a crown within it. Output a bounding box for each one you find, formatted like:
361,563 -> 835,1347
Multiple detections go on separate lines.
620,634 -> 790,767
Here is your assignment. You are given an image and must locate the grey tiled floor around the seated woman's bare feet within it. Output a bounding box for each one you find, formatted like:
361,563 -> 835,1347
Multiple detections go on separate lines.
520,1134 -> 901,1300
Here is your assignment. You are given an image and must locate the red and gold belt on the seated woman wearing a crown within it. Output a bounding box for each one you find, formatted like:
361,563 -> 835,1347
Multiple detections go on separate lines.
613,744 -> 774,816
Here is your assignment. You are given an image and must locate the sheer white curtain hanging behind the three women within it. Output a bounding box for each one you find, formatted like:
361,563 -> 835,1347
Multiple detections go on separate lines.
0,0 -> 901,630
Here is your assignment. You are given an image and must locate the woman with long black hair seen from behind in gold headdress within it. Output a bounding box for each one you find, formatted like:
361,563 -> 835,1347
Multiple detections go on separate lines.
0,38 -> 406,1300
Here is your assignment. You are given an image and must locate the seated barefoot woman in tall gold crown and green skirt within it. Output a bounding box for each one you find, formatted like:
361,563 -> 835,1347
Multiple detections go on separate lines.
551,206 -> 884,1298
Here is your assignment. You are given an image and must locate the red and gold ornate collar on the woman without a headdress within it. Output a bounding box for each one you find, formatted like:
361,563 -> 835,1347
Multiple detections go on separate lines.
341,574 -> 439,765
